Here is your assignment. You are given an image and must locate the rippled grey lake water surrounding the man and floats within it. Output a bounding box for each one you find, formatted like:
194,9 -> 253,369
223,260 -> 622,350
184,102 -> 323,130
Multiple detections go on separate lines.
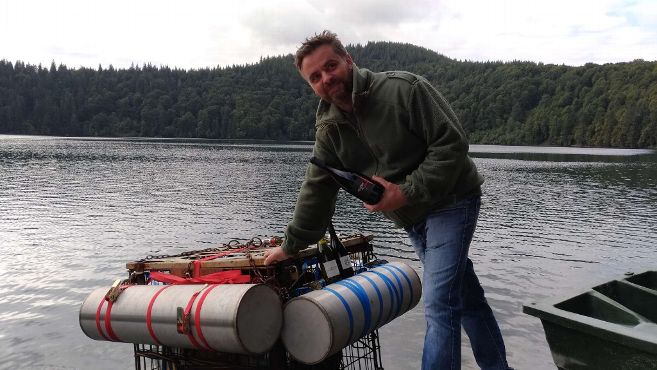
0,135 -> 657,370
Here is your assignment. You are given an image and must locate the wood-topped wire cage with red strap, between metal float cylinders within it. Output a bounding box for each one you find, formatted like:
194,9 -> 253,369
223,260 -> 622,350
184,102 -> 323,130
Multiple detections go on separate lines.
126,235 -> 386,370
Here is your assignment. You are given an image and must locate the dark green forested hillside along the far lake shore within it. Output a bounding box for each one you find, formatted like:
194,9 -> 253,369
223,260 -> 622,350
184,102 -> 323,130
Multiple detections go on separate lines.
0,42 -> 657,147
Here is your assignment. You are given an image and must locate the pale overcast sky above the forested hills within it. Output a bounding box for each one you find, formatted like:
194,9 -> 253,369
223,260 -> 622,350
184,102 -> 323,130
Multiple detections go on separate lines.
0,0 -> 657,69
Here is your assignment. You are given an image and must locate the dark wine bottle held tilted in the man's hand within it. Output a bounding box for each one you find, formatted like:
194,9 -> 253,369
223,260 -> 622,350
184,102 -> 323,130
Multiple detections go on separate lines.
310,157 -> 385,204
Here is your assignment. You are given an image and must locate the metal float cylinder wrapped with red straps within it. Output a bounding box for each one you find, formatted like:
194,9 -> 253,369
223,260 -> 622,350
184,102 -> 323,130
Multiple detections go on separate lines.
80,284 -> 283,354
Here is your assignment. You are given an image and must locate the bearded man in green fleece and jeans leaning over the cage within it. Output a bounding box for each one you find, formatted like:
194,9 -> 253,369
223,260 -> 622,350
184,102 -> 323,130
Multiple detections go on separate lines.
265,31 -> 508,370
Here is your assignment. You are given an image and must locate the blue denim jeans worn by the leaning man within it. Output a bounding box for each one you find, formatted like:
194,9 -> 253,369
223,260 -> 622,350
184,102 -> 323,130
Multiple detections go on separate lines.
406,196 -> 509,370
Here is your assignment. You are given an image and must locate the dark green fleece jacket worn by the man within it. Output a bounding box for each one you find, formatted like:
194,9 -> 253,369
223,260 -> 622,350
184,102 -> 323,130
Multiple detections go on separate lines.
283,65 -> 483,255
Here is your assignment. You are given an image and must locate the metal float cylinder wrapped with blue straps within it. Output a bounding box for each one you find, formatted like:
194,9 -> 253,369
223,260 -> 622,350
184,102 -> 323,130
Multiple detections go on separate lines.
281,262 -> 422,364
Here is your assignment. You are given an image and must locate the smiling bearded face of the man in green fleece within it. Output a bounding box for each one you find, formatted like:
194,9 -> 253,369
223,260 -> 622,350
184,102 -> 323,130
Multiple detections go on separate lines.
301,45 -> 353,106
